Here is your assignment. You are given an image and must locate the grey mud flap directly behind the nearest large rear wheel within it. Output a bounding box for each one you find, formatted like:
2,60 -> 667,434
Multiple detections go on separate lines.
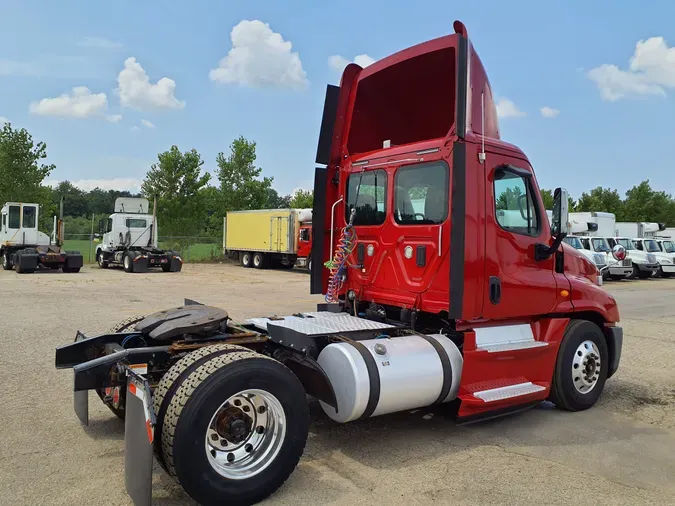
124,372 -> 155,506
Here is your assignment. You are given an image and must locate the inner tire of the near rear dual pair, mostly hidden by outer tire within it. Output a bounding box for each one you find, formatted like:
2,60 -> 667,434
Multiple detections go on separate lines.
153,343 -> 254,472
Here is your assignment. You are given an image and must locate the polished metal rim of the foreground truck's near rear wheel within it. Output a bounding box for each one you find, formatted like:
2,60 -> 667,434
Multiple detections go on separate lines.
209,390 -> 286,480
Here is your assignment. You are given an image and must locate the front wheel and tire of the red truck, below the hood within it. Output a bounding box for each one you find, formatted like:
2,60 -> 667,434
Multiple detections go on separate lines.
549,320 -> 609,411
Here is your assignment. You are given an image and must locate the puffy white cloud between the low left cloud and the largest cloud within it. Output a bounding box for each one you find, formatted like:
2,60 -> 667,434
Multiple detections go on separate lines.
116,57 -> 185,111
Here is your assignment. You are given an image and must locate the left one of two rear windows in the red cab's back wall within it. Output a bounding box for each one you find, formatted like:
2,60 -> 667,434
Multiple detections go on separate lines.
345,169 -> 387,225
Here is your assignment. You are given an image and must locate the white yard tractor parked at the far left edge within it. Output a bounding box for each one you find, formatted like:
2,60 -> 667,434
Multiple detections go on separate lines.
0,202 -> 83,274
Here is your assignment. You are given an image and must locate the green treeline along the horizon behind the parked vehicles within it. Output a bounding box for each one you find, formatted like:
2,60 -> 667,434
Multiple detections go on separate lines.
0,123 -> 675,237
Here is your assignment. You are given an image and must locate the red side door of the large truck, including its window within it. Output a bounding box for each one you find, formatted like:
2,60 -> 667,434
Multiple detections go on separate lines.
483,160 -> 564,319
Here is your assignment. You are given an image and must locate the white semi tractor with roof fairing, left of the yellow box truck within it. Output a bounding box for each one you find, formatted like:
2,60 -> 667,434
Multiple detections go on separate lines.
96,197 -> 183,272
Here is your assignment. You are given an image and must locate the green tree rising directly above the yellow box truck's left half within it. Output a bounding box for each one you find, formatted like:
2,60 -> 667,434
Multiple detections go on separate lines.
216,136 -> 273,211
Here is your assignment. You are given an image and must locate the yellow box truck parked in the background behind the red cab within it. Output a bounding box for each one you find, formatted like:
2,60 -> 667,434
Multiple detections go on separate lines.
223,209 -> 311,268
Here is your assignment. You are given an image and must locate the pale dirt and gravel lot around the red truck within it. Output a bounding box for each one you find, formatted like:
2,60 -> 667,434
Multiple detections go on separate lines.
0,264 -> 675,506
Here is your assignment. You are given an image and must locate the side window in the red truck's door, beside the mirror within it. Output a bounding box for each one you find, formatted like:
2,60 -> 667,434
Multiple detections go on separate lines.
494,167 -> 541,237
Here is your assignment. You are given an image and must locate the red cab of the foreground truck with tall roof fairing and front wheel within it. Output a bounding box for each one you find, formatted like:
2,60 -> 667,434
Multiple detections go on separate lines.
312,22 -> 622,418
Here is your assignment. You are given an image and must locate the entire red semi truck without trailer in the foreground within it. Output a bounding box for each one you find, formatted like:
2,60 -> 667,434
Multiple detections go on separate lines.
56,22 -> 623,505
